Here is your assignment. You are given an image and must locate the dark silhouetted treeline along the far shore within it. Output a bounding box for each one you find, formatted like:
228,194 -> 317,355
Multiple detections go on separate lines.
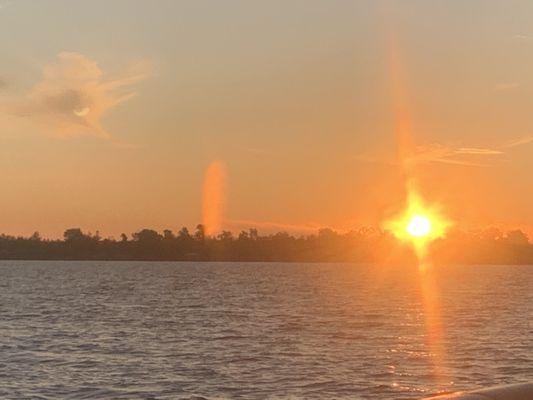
0,225 -> 533,264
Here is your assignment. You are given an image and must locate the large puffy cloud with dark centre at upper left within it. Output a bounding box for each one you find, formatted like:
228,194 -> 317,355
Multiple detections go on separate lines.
2,52 -> 149,138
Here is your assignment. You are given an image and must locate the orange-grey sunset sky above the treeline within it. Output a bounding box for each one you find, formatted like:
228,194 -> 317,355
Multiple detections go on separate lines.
0,0 -> 533,237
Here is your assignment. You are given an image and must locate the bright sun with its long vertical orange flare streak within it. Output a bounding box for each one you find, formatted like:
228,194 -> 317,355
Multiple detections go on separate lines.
384,10 -> 451,383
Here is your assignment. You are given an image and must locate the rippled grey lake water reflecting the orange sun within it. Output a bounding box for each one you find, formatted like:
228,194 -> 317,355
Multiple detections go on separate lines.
0,261 -> 533,399
